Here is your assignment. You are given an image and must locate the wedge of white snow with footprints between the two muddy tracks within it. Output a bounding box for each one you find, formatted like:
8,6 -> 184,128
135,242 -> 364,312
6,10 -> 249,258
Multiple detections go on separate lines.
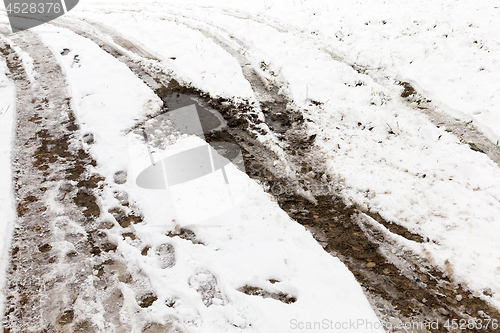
34,26 -> 383,332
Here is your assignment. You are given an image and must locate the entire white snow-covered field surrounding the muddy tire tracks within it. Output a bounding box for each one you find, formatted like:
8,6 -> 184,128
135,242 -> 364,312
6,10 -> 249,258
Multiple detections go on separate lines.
0,0 -> 500,332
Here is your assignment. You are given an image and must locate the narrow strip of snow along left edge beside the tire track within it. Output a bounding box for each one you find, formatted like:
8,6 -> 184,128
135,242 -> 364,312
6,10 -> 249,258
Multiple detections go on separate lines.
0,52 -> 16,326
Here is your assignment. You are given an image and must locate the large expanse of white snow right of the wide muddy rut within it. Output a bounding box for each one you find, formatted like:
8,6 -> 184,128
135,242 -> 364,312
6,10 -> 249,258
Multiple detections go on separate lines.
65,0 -> 500,307
